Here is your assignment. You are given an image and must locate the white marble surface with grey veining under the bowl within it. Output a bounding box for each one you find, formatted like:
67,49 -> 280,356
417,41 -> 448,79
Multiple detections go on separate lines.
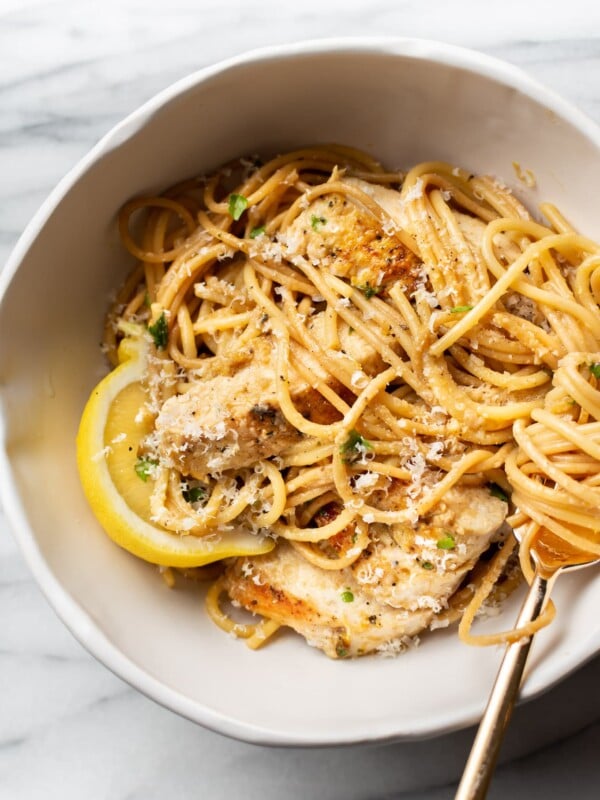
0,0 -> 600,800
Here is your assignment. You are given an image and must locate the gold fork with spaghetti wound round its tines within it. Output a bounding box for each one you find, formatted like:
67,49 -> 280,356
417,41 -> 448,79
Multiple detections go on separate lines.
455,528 -> 600,800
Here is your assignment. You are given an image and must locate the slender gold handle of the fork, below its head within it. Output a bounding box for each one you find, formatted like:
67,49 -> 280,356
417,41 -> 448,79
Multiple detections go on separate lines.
455,572 -> 555,800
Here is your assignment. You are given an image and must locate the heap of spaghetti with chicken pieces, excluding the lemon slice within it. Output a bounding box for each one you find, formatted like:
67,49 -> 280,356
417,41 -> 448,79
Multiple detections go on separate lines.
96,145 -> 600,657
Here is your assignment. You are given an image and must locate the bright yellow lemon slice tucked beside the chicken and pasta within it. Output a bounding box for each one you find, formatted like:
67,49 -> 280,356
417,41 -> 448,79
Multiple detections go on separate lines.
77,333 -> 274,567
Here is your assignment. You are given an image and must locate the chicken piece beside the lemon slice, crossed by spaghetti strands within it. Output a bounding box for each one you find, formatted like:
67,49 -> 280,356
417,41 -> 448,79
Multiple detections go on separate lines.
156,313 -> 393,479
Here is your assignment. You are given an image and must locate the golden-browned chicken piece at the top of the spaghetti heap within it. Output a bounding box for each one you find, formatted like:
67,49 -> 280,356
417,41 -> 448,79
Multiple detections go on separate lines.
281,179 -> 421,296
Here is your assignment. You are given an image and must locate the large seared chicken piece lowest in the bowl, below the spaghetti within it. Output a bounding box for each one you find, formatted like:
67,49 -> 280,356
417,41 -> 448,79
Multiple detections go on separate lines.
226,485 -> 507,658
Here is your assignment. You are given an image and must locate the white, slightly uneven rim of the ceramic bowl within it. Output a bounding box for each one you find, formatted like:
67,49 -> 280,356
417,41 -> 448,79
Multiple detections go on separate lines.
0,36 -> 600,747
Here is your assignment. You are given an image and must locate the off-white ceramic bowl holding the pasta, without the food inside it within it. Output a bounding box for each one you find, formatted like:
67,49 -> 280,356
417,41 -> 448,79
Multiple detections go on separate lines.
0,39 -> 600,745
